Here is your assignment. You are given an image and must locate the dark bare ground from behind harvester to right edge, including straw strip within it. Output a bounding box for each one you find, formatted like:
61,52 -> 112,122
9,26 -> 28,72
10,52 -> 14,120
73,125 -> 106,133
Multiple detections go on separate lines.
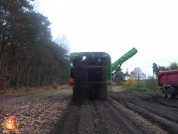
51,93 -> 178,134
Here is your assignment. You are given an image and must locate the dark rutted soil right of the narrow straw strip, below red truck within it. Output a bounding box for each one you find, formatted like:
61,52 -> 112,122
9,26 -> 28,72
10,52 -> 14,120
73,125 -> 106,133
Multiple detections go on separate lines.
109,93 -> 178,133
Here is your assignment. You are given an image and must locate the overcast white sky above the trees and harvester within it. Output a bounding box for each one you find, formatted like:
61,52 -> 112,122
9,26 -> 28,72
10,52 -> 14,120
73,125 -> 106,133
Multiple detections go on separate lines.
36,0 -> 178,75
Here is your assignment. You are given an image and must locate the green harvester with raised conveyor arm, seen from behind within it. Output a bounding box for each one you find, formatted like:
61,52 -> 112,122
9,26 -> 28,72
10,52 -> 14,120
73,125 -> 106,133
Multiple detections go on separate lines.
69,48 -> 138,104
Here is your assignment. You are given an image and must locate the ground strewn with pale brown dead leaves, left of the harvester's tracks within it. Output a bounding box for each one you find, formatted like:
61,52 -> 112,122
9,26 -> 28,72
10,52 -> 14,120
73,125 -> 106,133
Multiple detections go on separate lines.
0,90 -> 72,134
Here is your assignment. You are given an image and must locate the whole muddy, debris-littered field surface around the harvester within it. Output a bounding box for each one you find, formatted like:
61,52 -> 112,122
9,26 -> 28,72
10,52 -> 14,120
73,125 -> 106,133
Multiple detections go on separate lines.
0,90 -> 178,134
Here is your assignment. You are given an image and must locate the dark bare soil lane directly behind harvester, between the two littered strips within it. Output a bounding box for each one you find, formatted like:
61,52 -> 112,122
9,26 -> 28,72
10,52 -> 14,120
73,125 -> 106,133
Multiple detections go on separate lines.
52,100 -> 147,134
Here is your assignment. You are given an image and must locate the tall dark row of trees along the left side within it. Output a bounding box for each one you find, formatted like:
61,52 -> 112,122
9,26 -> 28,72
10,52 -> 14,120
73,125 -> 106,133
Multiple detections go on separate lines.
0,0 -> 69,89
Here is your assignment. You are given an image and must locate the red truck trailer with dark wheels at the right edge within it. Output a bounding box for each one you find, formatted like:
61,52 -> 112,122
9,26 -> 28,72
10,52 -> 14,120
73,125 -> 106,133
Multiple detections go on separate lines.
158,70 -> 178,98
